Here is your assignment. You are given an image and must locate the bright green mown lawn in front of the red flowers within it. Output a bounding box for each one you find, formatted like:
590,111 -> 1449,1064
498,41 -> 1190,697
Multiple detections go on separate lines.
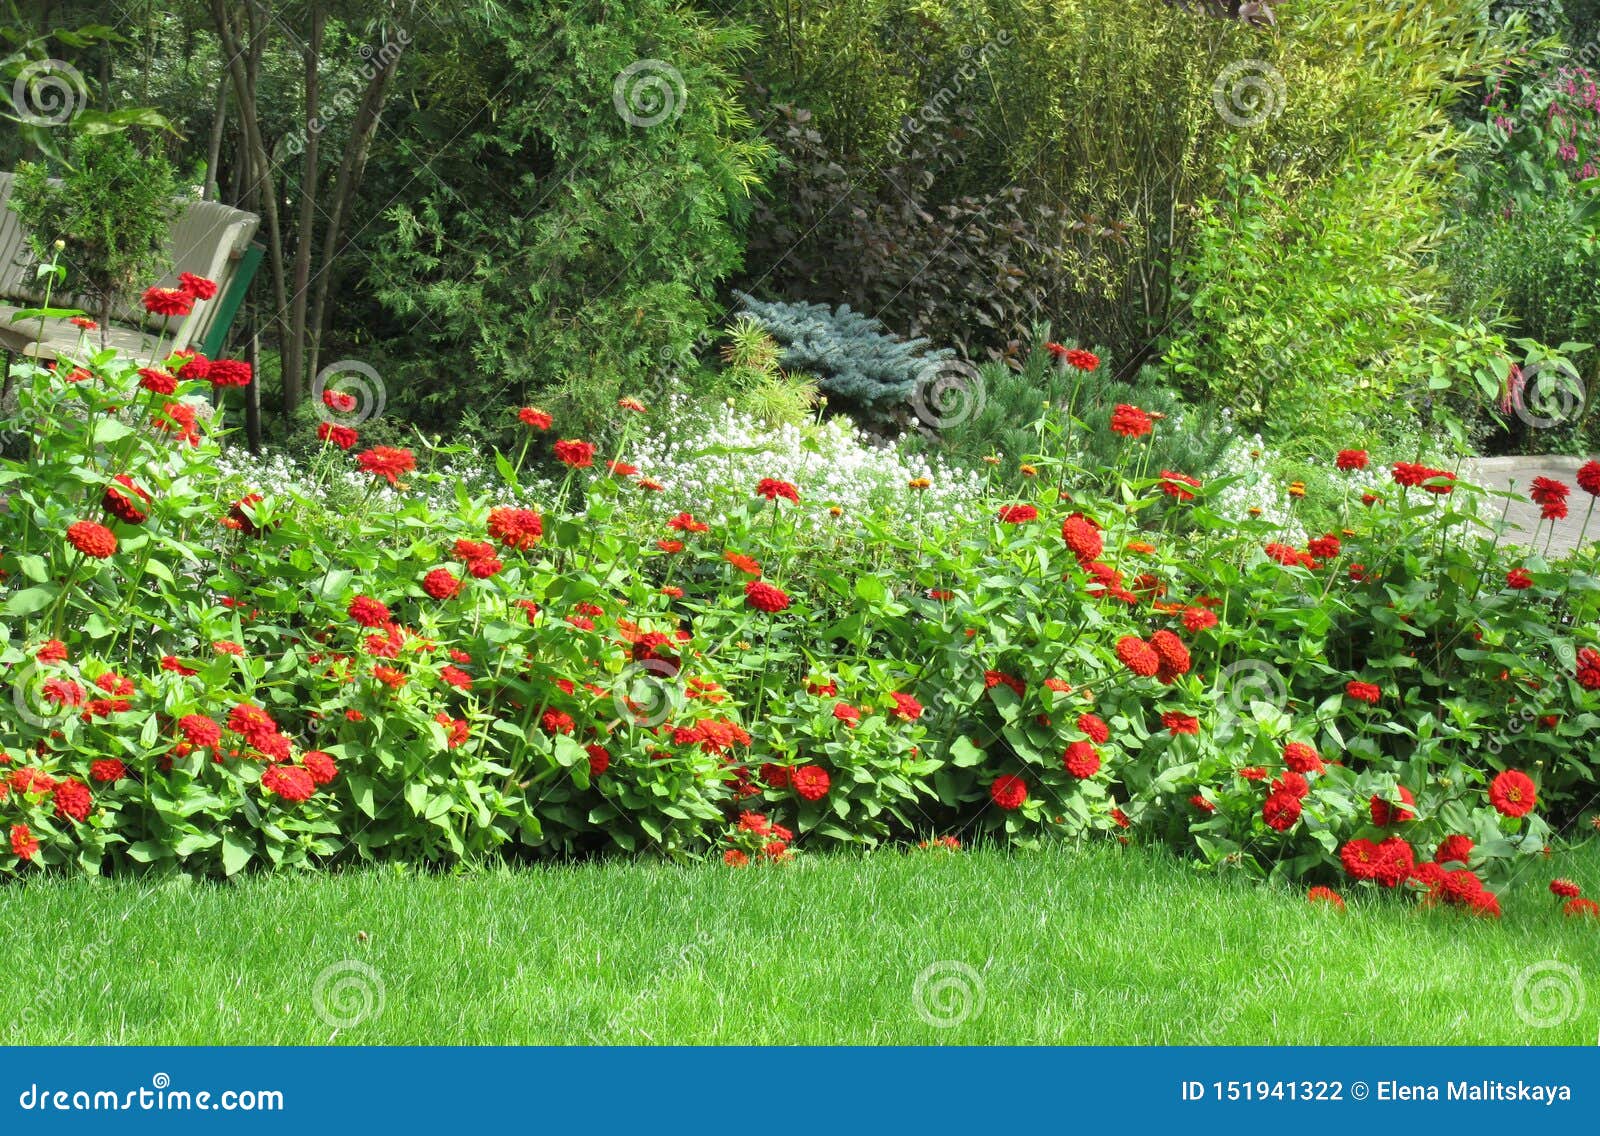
0,842 -> 1600,1045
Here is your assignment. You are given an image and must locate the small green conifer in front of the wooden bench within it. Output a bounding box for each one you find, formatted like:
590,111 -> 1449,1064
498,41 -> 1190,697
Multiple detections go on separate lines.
10,133 -> 178,323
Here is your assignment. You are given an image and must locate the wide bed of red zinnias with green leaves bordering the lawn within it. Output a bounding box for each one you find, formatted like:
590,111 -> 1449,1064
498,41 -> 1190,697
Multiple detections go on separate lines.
0,342 -> 1600,914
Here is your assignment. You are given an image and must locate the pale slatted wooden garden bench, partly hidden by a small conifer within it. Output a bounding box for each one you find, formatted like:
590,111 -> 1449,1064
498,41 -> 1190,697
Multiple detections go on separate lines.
0,173 -> 262,358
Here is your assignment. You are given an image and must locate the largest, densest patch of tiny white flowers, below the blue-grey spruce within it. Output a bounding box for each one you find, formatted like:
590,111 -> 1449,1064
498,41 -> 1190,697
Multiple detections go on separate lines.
622,400 -> 984,526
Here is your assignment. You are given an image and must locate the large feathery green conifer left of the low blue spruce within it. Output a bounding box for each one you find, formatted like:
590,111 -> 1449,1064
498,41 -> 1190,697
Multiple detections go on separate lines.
368,0 -> 768,432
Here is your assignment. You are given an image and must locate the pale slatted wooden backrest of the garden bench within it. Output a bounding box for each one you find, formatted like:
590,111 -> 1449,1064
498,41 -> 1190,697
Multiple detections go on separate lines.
0,173 -> 261,350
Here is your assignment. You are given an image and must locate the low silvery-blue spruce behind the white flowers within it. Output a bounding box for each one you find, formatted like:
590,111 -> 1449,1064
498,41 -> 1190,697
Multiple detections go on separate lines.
734,291 -> 952,422
